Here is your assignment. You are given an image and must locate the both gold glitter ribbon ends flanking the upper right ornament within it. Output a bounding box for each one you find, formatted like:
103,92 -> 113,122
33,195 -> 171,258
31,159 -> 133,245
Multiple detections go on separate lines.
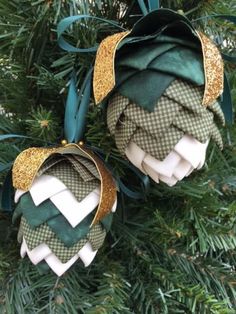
93,32 -> 224,106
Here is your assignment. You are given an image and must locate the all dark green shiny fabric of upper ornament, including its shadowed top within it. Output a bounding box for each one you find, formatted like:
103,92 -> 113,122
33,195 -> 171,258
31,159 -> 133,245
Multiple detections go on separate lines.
107,9 -> 205,112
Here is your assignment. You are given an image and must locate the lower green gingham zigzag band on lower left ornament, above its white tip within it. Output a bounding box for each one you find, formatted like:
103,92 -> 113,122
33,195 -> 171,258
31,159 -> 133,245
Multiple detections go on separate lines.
18,217 -> 106,263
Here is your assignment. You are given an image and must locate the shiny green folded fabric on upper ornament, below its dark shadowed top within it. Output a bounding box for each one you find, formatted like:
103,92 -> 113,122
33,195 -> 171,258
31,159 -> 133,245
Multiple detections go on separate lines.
116,35 -> 204,112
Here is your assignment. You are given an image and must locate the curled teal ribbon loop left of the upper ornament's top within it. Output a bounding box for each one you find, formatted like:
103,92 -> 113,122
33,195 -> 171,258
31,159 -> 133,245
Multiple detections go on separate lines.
57,15 -> 126,53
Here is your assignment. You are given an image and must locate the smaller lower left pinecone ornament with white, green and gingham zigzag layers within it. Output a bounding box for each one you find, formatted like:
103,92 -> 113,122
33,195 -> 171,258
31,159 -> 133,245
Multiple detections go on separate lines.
13,144 -> 116,276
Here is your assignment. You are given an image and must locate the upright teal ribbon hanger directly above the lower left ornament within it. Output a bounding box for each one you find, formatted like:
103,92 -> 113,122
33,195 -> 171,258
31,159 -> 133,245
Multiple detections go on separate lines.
64,68 -> 93,143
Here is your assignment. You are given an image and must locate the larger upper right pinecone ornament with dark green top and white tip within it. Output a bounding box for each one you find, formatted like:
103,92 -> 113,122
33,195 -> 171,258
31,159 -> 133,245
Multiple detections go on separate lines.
93,9 -> 225,186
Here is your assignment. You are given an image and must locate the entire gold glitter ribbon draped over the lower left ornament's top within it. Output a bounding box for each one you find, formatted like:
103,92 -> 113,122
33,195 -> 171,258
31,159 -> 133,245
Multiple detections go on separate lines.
12,144 -> 117,227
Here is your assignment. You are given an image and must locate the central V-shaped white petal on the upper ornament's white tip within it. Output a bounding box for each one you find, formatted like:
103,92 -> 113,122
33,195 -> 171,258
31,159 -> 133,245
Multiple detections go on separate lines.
143,151 -> 181,177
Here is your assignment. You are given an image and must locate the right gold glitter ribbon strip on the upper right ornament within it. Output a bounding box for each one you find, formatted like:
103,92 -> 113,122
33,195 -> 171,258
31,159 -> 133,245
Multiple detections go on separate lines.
197,32 -> 224,106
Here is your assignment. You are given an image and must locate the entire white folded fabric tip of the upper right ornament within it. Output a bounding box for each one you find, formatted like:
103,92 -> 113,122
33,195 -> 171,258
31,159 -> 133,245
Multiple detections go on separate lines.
125,135 -> 209,186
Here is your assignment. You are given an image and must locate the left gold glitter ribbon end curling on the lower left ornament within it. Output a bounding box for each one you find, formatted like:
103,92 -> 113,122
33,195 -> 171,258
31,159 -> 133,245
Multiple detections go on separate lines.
12,147 -> 58,191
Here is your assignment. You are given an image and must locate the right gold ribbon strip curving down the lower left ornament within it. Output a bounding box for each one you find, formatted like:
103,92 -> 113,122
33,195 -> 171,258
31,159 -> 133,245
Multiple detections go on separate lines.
67,144 -> 117,227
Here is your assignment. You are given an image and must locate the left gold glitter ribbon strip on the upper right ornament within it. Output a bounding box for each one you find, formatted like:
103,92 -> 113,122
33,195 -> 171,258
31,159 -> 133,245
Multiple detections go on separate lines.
93,31 -> 130,104
